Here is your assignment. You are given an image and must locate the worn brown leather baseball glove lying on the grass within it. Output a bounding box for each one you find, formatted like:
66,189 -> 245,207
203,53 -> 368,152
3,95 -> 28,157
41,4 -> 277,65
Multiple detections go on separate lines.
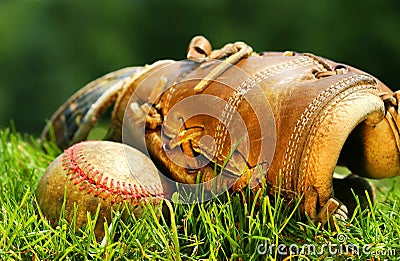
39,36 -> 400,223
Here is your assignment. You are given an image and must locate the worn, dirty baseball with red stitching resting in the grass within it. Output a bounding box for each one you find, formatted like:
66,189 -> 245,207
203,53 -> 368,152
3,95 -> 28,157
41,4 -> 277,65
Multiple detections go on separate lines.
36,141 -> 164,238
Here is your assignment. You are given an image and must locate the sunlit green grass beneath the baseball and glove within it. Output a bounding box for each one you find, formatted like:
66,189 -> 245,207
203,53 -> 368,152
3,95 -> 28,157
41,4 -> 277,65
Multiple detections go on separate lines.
0,125 -> 400,260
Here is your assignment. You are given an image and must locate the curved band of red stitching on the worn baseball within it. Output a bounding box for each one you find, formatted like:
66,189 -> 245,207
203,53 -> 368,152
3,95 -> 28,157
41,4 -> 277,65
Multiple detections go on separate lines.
62,143 -> 164,205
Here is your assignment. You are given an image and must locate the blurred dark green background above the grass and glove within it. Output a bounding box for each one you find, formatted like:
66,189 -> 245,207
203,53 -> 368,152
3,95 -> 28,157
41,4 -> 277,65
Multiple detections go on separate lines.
0,0 -> 400,135
